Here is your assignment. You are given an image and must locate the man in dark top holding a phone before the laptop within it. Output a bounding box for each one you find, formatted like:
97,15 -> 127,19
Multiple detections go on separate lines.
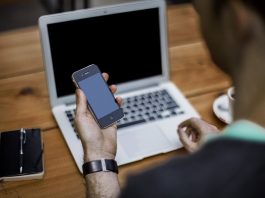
73,0 -> 265,197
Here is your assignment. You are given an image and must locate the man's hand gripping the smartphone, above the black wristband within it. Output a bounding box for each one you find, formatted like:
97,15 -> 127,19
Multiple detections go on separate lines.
75,73 -> 122,162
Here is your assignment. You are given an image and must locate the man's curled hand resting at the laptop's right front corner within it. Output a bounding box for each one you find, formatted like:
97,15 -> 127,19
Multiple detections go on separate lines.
177,118 -> 220,152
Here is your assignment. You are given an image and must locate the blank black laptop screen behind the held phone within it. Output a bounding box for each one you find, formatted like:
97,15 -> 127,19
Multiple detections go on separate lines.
48,8 -> 162,97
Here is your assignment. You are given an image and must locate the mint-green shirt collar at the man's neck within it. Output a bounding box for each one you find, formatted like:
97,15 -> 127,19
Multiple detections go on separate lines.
206,120 -> 265,143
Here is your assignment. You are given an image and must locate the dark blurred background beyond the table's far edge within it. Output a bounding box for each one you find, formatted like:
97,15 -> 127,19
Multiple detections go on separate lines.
0,0 -> 191,32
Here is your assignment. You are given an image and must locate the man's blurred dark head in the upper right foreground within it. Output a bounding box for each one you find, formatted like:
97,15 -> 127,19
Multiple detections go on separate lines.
194,0 -> 265,76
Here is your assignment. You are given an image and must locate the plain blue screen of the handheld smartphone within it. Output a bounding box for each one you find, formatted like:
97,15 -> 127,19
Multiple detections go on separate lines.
78,73 -> 119,119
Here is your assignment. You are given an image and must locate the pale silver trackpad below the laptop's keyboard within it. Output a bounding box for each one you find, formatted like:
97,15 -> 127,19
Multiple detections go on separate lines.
119,126 -> 171,158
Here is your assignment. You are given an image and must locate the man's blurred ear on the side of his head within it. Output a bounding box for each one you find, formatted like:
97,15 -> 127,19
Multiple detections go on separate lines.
229,1 -> 260,42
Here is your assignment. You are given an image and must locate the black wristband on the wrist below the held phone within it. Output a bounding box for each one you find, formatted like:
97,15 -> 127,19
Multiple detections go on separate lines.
83,159 -> 119,176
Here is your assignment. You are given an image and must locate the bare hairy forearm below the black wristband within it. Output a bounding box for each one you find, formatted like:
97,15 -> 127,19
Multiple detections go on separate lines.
86,172 -> 120,198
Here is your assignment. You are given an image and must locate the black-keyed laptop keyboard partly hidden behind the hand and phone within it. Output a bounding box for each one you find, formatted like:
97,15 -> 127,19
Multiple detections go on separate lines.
65,90 -> 184,136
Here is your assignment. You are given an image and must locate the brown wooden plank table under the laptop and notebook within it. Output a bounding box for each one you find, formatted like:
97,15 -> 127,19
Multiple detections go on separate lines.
0,5 -> 231,198
